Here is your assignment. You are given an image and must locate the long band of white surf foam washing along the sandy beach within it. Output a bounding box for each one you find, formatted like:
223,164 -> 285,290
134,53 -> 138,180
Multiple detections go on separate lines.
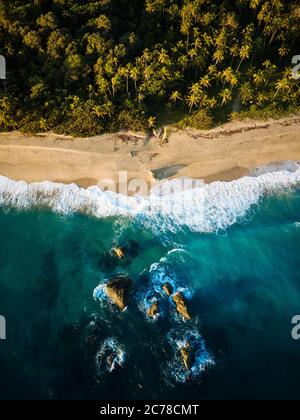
0,162 -> 300,232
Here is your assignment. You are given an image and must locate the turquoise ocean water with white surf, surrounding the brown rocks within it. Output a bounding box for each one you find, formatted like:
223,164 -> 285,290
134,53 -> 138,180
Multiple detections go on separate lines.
0,166 -> 300,399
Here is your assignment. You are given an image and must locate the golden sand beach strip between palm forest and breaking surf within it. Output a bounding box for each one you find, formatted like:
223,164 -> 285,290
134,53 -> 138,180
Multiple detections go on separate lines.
0,115 -> 300,194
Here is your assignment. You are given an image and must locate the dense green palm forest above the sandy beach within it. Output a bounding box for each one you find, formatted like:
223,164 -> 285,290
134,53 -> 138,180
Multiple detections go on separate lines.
0,0 -> 300,136
